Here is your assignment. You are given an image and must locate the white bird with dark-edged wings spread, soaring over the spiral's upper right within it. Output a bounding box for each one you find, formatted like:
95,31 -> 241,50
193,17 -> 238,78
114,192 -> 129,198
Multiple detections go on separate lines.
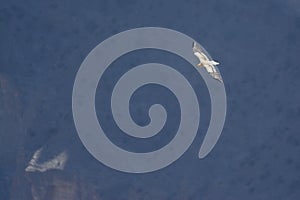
193,42 -> 223,83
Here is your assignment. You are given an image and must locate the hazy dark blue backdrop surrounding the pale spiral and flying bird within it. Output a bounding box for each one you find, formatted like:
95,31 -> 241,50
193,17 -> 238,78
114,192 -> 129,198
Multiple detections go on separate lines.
0,0 -> 300,200
